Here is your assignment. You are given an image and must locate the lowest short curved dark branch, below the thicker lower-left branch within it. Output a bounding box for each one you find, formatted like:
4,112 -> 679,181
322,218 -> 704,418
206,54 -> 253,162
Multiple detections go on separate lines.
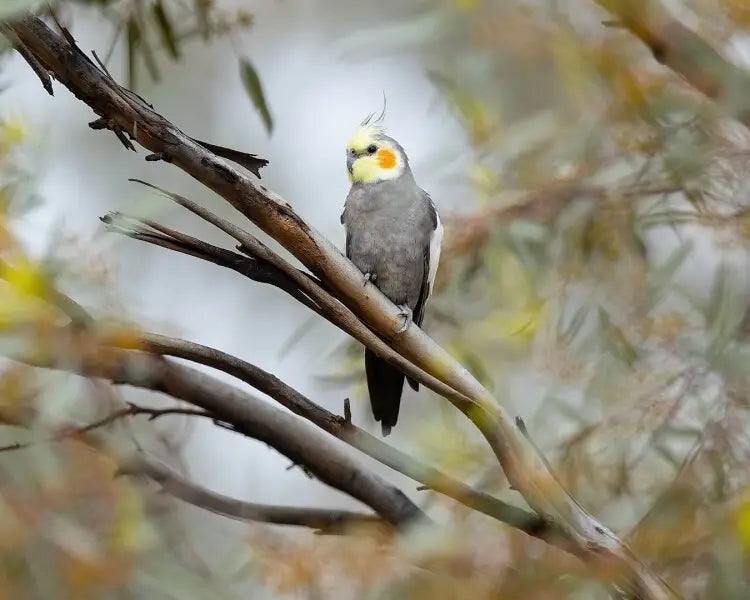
118,456 -> 384,533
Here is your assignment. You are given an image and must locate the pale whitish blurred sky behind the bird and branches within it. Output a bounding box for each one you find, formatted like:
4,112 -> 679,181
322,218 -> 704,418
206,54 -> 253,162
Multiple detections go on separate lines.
0,0 -> 471,584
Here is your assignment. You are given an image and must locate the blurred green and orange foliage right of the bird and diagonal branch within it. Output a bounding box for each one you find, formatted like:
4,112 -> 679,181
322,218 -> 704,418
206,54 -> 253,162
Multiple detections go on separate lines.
332,0 -> 750,598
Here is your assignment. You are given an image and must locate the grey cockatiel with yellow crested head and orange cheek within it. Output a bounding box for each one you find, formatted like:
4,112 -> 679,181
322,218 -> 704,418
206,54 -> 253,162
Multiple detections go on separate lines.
341,109 -> 443,436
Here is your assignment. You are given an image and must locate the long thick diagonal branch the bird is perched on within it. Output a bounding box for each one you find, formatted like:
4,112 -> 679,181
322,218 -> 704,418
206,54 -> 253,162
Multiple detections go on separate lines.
4,16 -> 674,600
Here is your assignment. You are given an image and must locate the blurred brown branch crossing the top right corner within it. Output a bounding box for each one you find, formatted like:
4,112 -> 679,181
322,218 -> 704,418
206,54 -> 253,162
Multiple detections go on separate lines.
595,0 -> 750,127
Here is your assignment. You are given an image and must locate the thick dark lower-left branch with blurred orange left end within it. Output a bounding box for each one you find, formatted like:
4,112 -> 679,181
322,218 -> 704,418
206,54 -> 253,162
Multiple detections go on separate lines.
6,328 -> 427,528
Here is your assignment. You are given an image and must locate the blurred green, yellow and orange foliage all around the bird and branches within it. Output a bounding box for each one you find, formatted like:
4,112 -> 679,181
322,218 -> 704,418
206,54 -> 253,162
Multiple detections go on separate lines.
0,0 -> 750,599
